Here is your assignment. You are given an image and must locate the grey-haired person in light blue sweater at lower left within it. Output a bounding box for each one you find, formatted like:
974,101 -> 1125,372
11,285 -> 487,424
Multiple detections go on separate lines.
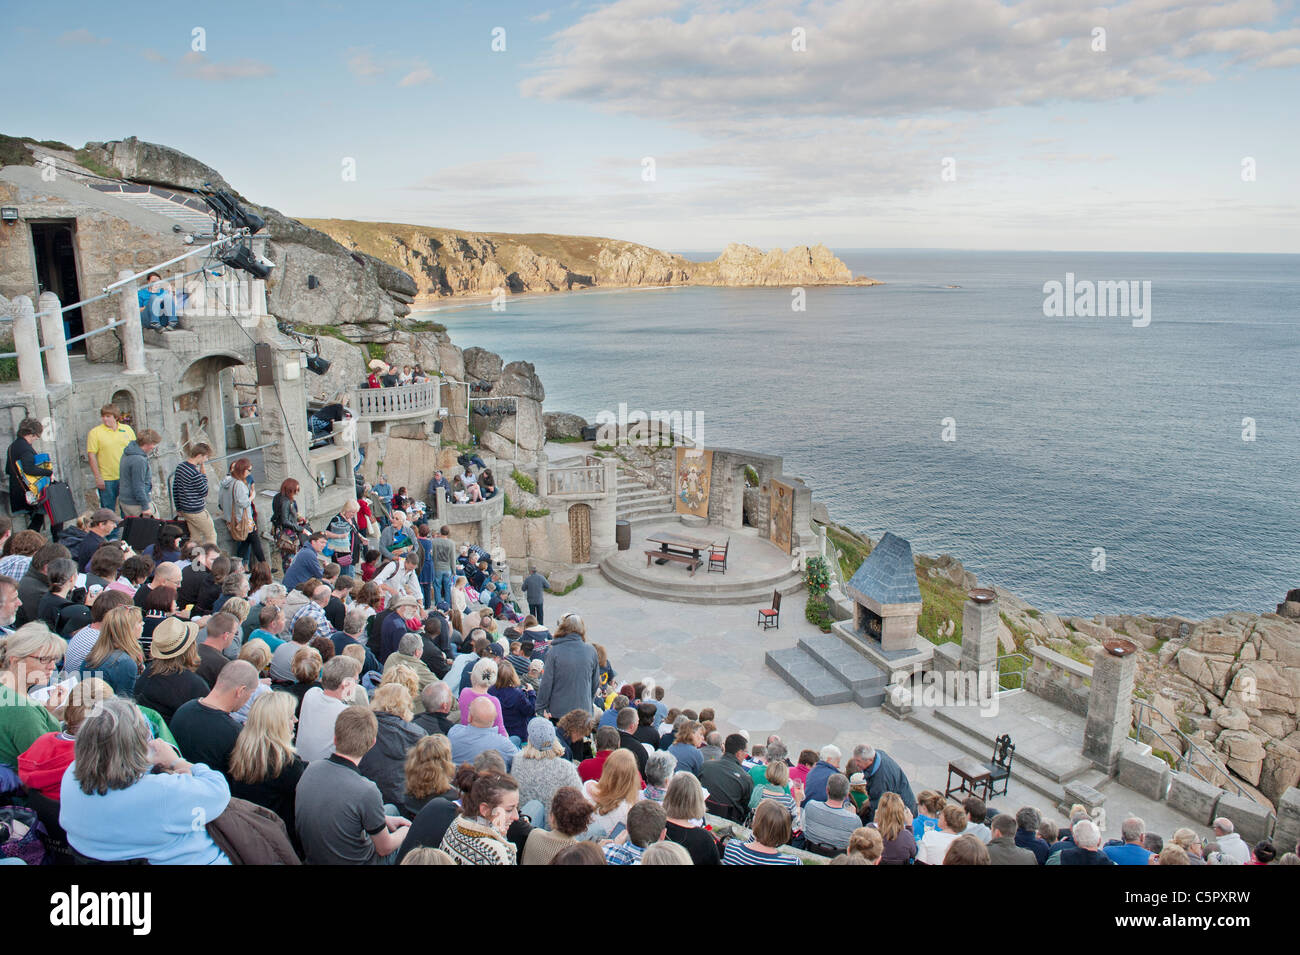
59,698 -> 230,865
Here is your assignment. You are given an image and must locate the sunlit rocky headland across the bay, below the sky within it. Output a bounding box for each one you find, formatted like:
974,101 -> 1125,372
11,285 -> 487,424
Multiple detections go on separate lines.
302,218 -> 880,305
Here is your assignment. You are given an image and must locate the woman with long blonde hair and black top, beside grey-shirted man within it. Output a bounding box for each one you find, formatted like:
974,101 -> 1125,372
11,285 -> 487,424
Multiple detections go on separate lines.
226,686 -> 307,847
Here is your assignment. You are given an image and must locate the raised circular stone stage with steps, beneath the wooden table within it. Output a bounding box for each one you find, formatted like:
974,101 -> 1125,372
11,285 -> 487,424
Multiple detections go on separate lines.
601,516 -> 803,607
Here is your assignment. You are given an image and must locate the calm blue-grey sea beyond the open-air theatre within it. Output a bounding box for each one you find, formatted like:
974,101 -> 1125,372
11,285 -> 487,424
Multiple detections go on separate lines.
421,249 -> 1300,617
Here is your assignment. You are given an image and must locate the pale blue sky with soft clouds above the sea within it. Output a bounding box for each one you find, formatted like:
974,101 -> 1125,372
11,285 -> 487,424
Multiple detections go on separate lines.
12,0 -> 1300,253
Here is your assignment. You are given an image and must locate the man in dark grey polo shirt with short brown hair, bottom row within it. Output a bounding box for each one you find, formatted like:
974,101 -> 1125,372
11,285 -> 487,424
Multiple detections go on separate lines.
294,701 -> 411,865
